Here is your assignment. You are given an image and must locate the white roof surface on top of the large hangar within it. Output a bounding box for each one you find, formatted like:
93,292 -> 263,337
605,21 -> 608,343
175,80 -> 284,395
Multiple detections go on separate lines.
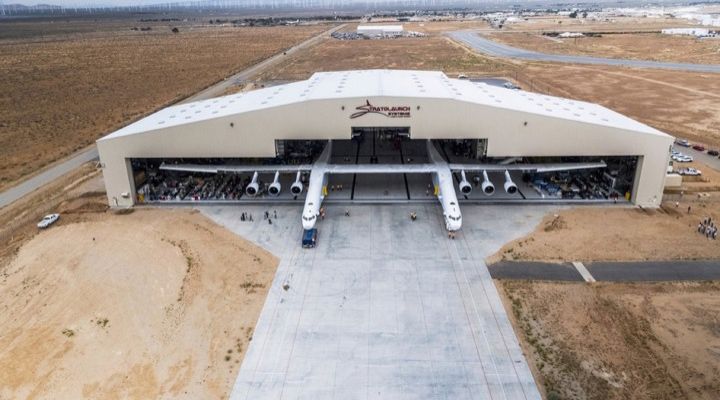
100,70 -> 665,140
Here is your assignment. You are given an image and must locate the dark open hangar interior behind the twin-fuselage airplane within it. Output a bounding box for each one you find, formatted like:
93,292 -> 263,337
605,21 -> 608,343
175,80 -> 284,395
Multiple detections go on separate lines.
131,133 -> 638,203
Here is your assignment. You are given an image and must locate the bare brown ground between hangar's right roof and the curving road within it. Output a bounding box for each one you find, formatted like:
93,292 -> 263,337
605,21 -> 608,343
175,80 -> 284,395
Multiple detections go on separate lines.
506,63 -> 720,146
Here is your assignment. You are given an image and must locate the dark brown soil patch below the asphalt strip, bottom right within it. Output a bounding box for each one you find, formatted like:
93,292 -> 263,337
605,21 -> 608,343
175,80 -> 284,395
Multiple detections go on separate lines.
496,281 -> 720,400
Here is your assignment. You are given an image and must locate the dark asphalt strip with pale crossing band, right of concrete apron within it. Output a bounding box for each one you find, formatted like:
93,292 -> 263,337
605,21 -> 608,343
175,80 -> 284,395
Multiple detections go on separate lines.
488,260 -> 720,282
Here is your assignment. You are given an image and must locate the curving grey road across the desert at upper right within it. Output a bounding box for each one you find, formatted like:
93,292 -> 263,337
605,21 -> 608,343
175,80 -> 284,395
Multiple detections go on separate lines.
449,31 -> 720,73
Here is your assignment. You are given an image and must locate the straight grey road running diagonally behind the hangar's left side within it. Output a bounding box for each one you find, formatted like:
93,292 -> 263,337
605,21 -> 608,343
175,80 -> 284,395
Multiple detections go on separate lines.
0,25 -> 344,208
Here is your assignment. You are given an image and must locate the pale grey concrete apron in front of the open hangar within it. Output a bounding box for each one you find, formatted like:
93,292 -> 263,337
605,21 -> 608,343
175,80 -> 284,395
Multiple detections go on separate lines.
199,204 -> 549,400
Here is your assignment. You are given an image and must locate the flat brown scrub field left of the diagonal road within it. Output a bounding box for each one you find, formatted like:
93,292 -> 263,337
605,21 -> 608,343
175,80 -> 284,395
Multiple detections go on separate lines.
0,18 -> 329,189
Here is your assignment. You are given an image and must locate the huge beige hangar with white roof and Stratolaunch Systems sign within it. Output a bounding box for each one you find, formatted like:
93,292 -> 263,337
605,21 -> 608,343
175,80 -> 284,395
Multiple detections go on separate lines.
97,70 -> 673,225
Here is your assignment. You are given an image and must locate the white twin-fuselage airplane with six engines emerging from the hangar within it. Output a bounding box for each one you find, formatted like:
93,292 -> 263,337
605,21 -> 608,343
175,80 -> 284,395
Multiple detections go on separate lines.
160,140 -> 607,232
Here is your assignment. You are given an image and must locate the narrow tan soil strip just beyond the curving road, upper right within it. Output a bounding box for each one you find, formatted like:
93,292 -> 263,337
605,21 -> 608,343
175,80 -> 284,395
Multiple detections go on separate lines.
489,32 -> 720,64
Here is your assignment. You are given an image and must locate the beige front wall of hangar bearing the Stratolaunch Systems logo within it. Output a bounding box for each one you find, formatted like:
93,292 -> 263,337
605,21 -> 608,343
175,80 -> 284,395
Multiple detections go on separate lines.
98,79 -> 673,206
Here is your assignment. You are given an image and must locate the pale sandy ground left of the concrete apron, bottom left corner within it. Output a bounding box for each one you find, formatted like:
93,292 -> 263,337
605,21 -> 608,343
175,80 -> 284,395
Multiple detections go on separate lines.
0,206 -> 277,399
